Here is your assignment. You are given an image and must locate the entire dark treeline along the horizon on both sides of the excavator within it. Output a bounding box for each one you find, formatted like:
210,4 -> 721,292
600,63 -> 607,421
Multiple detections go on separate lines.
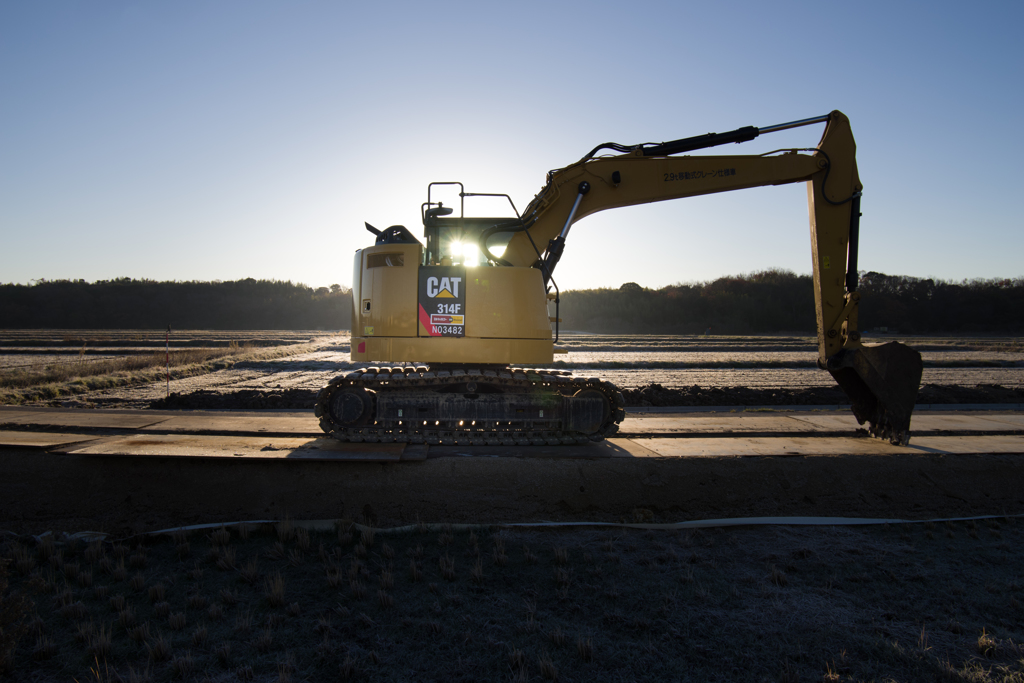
0,269 -> 1024,334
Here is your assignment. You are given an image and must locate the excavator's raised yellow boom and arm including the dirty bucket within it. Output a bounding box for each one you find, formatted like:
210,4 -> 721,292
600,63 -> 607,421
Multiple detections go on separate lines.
491,112 -> 923,443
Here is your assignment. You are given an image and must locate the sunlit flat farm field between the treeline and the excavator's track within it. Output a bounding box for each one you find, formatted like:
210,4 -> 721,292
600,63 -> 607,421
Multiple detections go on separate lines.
0,330 -> 1024,408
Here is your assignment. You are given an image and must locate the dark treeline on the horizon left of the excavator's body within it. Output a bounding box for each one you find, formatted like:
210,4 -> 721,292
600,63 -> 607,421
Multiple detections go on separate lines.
0,278 -> 351,330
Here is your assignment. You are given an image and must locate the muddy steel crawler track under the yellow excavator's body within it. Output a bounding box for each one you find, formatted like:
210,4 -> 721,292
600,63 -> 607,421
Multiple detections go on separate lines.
315,367 -> 626,445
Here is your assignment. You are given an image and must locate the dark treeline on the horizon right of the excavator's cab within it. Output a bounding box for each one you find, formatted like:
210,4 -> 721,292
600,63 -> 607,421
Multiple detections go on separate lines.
559,269 -> 1024,334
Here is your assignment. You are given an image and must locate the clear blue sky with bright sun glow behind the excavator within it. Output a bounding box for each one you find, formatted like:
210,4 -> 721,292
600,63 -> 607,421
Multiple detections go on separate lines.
0,0 -> 1024,289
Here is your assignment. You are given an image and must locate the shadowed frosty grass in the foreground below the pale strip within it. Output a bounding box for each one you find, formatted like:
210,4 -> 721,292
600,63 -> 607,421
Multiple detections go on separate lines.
2,520 -> 1024,681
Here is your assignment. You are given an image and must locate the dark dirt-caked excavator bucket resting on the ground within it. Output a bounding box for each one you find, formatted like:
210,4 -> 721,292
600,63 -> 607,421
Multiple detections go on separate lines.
827,342 -> 924,445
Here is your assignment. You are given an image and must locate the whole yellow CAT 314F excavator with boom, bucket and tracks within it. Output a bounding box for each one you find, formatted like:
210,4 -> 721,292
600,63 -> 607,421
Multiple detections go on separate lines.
315,112 -> 922,445
